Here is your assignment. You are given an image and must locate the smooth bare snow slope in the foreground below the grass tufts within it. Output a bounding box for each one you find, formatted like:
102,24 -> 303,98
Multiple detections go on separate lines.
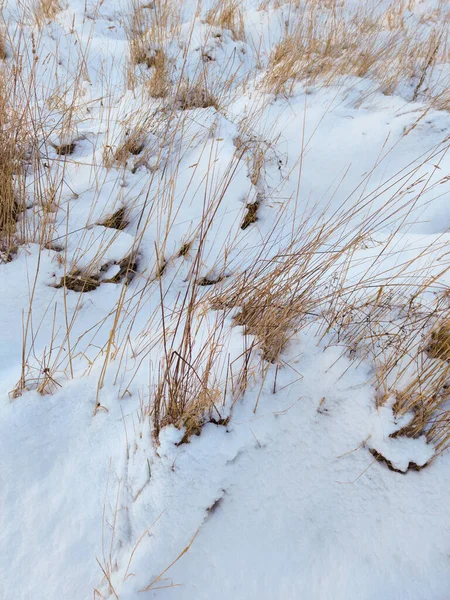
0,335 -> 450,599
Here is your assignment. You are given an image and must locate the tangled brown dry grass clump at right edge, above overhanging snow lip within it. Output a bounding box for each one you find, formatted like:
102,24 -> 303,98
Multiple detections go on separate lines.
327,248 -> 450,453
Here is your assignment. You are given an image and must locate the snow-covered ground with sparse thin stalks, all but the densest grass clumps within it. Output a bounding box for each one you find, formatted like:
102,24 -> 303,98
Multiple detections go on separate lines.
0,0 -> 450,600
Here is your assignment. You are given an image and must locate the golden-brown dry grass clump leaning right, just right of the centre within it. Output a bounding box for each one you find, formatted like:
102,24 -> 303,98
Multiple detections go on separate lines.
212,213 -> 361,363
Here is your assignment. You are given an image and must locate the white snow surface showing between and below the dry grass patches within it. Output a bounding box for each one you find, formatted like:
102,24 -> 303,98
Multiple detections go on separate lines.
0,0 -> 450,600
